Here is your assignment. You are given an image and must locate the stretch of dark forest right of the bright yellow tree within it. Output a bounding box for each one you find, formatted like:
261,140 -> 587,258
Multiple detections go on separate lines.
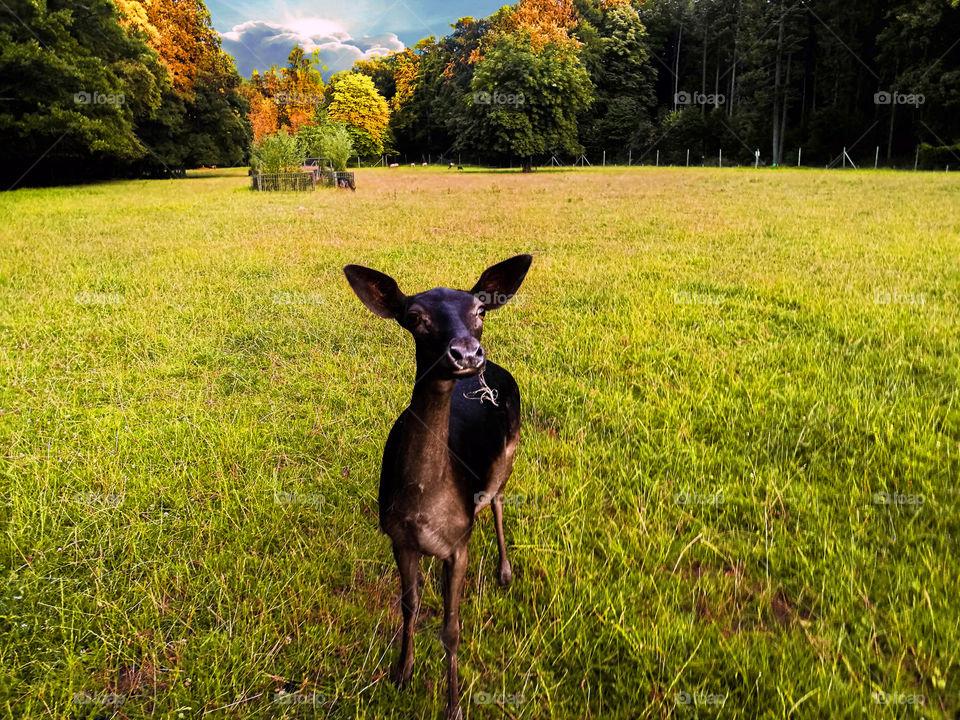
344,0 -> 960,169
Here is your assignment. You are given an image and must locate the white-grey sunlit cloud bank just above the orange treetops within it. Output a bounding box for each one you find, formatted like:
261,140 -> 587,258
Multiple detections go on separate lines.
221,18 -> 404,78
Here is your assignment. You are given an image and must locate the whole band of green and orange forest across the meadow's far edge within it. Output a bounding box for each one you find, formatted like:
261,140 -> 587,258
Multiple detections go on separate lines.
0,0 -> 960,184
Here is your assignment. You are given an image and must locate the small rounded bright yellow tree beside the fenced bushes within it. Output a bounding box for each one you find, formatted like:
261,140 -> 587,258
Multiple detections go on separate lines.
326,72 -> 390,157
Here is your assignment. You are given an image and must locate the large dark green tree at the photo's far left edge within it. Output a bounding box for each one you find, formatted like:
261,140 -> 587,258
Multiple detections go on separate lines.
0,0 -> 165,184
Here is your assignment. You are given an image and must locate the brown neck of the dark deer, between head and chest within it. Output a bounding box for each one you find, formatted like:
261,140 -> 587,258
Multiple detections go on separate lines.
404,380 -> 454,482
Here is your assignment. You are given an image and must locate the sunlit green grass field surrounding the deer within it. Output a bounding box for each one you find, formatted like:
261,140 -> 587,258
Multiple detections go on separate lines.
0,168 -> 960,719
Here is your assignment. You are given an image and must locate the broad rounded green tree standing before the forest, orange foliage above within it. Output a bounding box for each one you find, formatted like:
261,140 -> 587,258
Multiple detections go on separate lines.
458,34 -> 591,172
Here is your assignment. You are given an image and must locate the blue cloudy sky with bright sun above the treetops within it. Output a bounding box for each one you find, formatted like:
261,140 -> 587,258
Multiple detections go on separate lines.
207,0 -> 509,78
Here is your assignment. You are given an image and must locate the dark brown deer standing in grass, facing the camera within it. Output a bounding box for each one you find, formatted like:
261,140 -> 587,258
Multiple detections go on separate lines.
343,255 -> 533,720
